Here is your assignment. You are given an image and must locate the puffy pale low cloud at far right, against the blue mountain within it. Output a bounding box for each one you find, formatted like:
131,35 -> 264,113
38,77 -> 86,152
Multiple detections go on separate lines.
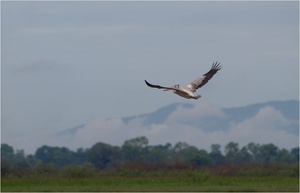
229,107 -> 299,148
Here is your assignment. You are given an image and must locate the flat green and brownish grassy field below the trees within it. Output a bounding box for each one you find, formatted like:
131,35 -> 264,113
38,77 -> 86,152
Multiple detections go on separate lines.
1,165 -> 299,192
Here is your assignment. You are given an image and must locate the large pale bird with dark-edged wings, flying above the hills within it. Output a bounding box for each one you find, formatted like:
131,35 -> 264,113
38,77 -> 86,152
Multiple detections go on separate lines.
145,62 -> 221,99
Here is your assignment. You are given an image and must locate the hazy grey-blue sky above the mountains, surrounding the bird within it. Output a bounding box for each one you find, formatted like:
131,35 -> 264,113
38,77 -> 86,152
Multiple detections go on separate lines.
1,1 -> 299,152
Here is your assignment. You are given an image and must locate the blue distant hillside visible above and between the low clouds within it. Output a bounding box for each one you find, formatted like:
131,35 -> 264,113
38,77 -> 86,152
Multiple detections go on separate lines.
55,100 -> 299,137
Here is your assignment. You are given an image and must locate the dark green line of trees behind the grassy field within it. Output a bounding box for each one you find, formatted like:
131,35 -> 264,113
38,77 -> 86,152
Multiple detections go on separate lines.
1,136 -> 299,175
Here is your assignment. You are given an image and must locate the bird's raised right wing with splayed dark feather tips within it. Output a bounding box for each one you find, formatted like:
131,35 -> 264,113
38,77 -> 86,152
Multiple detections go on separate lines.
187,62 -> 221,92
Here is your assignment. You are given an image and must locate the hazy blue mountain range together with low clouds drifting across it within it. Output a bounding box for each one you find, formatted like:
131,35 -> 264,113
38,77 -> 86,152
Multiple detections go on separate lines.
52,100 -> 299,151
